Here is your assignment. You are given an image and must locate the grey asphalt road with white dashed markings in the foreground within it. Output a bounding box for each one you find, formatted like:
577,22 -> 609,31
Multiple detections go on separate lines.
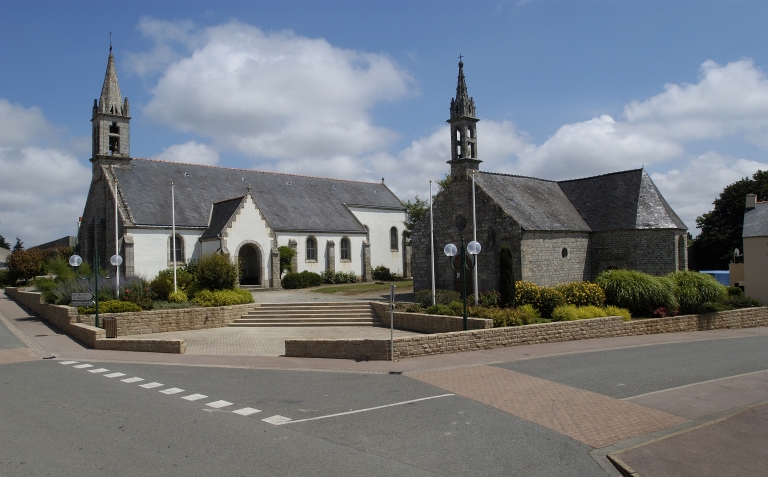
0,306 -> 768,477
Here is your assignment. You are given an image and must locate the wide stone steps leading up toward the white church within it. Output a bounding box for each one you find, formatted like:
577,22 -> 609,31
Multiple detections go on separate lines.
228,302 -> 382,327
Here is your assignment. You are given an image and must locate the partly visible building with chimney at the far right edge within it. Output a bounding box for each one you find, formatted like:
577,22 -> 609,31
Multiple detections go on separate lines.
731,194 -> 768,304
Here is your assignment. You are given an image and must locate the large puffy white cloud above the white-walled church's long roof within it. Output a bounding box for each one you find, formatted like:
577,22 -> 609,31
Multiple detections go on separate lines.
140,22 -> 411,160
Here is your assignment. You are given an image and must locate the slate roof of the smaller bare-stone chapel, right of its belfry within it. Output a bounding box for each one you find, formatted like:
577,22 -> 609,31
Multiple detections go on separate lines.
475,169 -> 687,232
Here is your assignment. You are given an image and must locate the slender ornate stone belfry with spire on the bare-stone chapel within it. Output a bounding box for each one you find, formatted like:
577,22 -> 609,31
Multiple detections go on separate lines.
447,56 -> 483,181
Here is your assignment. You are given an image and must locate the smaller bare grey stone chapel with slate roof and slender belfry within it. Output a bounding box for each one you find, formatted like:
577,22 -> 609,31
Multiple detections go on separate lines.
411,62 -> 687,292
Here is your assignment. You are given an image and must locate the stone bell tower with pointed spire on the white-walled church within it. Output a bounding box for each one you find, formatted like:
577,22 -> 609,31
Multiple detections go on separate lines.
91,45 -> 131,164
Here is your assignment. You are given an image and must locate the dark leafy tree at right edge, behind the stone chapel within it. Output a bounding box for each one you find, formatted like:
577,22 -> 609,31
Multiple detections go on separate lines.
690,171 -> 768,270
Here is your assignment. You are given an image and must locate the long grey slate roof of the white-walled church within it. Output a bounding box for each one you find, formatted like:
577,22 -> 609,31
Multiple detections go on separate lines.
113,159 -> 404,233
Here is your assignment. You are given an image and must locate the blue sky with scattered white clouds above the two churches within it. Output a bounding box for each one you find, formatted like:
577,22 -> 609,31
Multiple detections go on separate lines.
0,0 -> 768,246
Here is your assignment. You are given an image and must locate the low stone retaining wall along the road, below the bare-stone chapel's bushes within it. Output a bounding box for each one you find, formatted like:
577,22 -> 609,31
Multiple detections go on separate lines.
285,307 -> 768,359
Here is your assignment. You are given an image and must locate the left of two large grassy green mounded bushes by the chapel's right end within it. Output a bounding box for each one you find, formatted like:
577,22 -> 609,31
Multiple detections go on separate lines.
595,270 -> 677,316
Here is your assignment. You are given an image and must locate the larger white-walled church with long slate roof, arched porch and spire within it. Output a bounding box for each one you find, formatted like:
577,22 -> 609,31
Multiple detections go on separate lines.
78,48 -> 407,287
